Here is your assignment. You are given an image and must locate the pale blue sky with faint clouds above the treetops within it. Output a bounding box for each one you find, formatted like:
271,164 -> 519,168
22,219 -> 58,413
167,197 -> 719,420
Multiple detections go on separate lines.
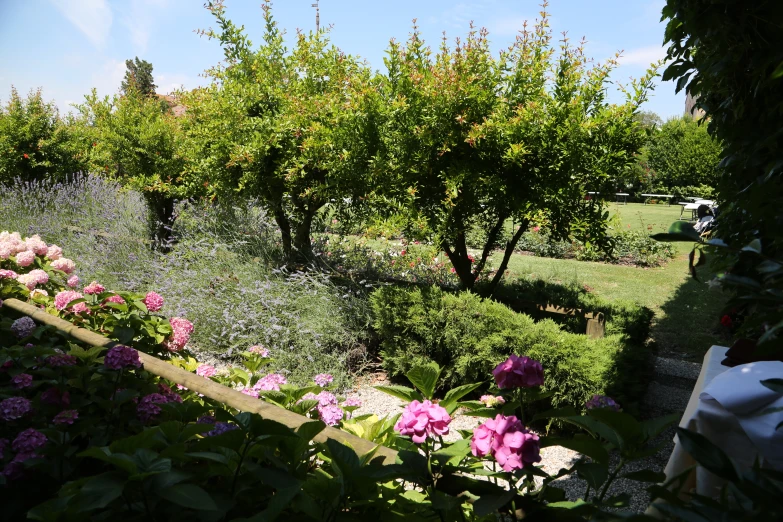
0,0 -> 685,119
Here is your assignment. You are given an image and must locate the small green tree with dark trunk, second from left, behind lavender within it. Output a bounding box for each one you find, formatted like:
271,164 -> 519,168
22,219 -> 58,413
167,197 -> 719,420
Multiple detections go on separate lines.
78,90 -> 189,242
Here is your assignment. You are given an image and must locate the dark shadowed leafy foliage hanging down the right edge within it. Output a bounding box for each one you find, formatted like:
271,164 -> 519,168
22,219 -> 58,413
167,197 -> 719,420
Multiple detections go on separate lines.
663,0 -> 783,349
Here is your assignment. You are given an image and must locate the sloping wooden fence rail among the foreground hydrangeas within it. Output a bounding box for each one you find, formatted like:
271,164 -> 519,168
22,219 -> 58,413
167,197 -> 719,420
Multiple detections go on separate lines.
3,299 -> 397,464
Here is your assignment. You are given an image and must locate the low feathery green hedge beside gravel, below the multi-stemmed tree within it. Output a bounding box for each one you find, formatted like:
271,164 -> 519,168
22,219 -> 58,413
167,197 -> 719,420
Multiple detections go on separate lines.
371,287 -> 649,409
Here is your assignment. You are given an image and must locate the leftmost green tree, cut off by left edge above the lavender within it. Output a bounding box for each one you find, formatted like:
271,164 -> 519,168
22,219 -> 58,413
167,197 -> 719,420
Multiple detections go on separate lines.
0,89 -> 86,182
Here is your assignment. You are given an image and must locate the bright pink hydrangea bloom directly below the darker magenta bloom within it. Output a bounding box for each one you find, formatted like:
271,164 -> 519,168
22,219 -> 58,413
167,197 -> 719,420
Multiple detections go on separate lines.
470,415 -> 541,471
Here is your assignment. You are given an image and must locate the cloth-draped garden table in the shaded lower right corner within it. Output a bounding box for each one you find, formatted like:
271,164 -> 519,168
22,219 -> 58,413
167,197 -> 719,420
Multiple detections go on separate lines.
664,346 -> 783,497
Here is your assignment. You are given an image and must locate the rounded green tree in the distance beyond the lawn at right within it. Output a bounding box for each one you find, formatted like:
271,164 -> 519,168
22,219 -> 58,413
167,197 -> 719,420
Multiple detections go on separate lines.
647,115 -> 721,189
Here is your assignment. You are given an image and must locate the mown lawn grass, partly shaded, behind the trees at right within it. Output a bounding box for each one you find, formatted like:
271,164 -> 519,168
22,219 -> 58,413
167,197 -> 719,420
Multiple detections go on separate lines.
493,203 -> 731,360
